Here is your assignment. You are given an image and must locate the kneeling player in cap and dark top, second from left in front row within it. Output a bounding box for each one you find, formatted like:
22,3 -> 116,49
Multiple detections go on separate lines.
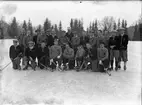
23,41 -> 37,70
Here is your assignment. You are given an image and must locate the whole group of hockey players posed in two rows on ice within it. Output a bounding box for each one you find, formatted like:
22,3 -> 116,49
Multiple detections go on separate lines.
9,28 -> 128,71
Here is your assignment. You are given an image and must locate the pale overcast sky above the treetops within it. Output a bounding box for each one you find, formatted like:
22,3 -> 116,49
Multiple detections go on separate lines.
0,1 -> 141,30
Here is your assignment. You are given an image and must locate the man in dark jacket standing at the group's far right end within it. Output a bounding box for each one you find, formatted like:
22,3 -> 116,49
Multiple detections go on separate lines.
119,28 -> 128,70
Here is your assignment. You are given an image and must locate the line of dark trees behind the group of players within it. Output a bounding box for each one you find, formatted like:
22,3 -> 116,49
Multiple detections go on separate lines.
0,16 -> 142,40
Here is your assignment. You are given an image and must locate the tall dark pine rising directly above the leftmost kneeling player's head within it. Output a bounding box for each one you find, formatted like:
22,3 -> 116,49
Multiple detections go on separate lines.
8,17 -> 19,38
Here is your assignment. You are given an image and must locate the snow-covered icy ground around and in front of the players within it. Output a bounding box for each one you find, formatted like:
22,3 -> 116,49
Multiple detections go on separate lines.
0,40 -> 142,105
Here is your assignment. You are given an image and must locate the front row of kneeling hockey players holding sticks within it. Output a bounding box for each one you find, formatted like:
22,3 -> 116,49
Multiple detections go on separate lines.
9,39 -> 109,72
